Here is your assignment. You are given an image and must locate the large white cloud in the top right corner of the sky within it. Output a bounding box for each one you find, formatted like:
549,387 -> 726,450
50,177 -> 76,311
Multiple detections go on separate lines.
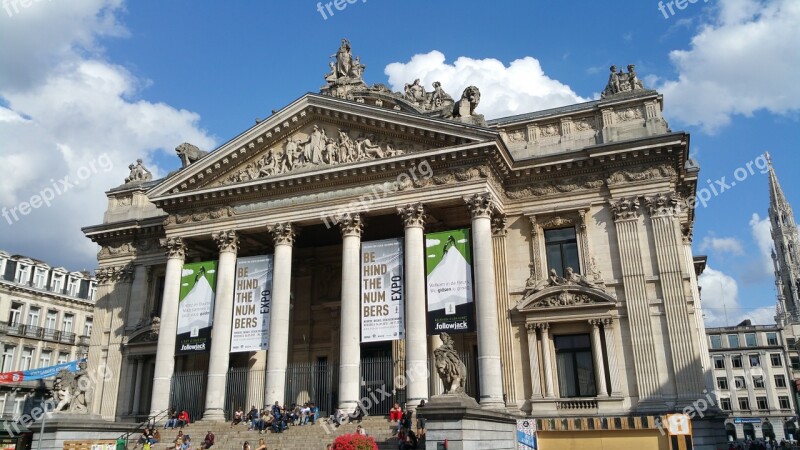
657,0 -> 800,133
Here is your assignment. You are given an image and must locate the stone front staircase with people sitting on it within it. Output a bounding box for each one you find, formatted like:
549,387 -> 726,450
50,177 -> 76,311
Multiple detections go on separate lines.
143,416 -> 400,450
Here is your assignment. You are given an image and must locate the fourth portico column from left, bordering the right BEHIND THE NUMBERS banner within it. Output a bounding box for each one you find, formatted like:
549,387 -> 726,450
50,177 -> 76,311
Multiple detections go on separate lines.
339,214 -> 362,414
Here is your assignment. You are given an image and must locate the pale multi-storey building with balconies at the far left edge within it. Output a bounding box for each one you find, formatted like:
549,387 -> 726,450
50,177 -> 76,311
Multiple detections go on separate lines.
0,250 -> 96,419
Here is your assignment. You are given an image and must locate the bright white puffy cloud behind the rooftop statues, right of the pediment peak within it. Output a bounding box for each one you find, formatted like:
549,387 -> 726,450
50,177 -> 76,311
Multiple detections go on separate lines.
384,50 -> 589,119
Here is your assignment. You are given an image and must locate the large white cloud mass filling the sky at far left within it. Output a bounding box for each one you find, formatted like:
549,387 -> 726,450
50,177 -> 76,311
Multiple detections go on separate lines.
0,0 -> 214,270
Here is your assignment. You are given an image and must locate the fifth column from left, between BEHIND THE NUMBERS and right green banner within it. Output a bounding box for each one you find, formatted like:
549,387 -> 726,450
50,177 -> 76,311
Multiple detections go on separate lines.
397,203 -> 428,408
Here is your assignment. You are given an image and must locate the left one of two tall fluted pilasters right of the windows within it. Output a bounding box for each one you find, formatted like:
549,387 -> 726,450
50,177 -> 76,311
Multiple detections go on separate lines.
610,197 -> 661,401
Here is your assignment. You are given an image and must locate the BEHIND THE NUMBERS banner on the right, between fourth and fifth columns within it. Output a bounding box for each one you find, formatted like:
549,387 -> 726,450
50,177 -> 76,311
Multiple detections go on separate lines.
361,238 -> 405,342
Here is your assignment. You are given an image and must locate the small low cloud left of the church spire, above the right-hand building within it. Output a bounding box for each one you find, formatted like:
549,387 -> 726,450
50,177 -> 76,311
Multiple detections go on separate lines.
698,266 -> 775,327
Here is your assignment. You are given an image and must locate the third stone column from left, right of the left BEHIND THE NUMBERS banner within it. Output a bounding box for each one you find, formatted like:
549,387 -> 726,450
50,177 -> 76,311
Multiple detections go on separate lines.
264,223 -> 295,404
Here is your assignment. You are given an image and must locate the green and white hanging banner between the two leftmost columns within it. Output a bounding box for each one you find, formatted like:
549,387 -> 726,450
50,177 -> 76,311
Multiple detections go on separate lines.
175,261 -> 217,355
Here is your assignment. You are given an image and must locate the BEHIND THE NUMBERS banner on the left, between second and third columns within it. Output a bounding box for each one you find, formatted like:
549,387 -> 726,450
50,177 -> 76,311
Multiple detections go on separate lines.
231,255 -> 272,353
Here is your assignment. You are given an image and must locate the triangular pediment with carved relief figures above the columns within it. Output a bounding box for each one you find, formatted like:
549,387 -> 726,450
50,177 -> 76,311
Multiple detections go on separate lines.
148,94 -> 497,200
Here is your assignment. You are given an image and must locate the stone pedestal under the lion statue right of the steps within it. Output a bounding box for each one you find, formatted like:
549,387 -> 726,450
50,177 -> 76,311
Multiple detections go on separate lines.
417,394 -> 517,450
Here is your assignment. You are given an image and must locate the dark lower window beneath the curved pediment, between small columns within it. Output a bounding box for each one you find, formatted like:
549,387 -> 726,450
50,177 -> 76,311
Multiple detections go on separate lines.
554,334 -> 597,398
